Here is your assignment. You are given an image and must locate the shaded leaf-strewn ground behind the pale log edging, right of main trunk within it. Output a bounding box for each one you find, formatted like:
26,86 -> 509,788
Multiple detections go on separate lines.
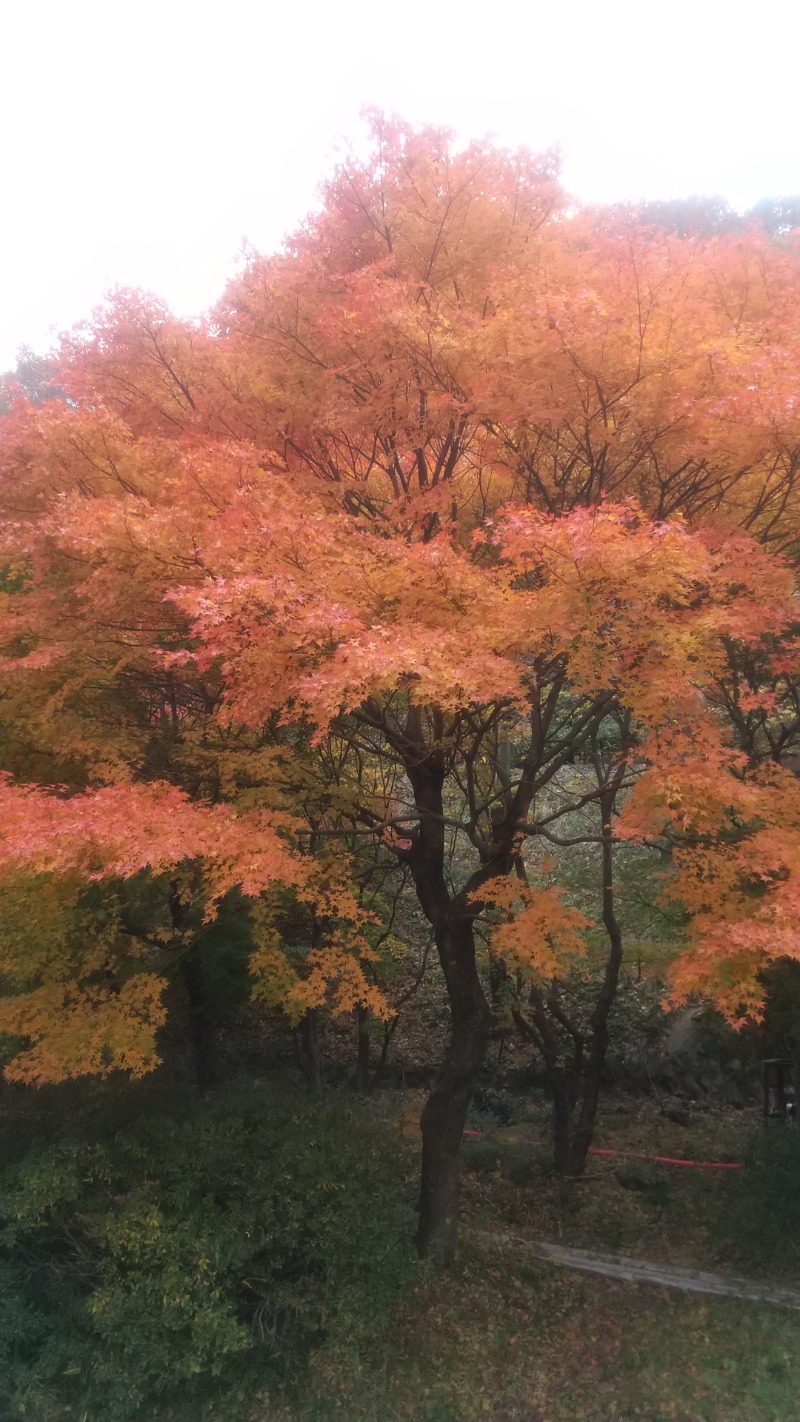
465,1101 -> 800,1284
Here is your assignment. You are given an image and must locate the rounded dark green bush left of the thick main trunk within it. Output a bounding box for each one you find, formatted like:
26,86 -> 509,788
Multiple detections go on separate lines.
0,1091 -> 413,1422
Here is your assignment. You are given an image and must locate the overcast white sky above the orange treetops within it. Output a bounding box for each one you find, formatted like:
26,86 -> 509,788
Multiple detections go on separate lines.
0,0 -> 800,370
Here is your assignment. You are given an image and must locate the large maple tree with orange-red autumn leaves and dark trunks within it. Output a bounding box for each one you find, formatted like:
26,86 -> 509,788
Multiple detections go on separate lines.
0,115 -> 800,1263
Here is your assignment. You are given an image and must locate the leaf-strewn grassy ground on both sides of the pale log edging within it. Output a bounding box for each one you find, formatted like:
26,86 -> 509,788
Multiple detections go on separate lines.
291,1103 -> 800,1422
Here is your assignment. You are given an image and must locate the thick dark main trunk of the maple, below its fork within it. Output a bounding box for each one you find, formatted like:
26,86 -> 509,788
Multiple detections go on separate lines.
416,919 -> 490,1268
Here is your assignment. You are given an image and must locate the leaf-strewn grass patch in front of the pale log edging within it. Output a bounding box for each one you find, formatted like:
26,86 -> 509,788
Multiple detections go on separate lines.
302,1249 -> 800,1422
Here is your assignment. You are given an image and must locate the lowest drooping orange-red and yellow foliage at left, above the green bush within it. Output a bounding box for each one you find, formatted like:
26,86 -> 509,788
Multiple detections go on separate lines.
0,776 -> 385,1082
